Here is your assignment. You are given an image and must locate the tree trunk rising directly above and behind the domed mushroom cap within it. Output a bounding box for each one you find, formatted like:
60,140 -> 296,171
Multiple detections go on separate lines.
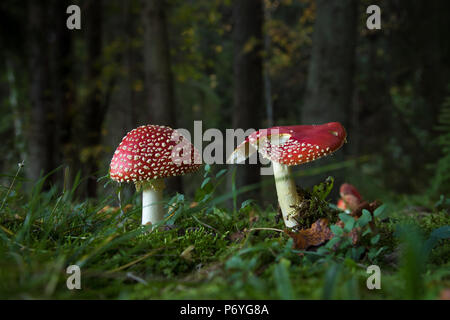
140,0 -> 182,192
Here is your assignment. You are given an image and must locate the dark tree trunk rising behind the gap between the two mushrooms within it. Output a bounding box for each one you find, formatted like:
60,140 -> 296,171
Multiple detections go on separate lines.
232,0 -> 264,204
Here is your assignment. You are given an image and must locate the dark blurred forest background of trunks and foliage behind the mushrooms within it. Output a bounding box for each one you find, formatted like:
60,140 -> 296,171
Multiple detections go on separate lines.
0,0 -> 450,205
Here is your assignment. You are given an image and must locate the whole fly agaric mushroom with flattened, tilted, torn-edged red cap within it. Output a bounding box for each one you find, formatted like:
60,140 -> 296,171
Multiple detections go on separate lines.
227,122 -> 347,228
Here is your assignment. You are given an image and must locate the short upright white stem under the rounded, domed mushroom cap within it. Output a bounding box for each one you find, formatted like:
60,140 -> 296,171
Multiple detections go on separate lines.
142,179 -> 164,225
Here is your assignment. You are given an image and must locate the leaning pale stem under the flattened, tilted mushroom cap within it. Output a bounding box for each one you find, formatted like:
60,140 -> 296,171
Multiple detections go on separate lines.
272,162 -> 300,228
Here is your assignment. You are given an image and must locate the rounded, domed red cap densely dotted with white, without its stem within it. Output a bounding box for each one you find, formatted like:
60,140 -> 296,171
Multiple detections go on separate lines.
109,125 -> 200,182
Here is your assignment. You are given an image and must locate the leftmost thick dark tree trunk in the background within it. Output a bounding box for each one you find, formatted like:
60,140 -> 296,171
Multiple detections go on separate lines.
26,1 -> 54,188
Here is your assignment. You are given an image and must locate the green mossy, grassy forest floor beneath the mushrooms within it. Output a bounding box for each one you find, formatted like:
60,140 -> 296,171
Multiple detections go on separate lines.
0,166 -> 450,299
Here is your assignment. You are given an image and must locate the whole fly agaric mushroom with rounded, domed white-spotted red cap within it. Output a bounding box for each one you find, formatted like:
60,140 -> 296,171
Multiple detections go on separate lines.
109,125 -> 200,225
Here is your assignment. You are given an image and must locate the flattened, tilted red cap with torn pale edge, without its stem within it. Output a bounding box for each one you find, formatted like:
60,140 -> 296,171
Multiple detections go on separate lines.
229,122 -> 347,166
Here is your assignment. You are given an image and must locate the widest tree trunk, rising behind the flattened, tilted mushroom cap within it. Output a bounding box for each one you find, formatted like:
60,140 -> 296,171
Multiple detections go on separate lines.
302,0 -> 357,126
